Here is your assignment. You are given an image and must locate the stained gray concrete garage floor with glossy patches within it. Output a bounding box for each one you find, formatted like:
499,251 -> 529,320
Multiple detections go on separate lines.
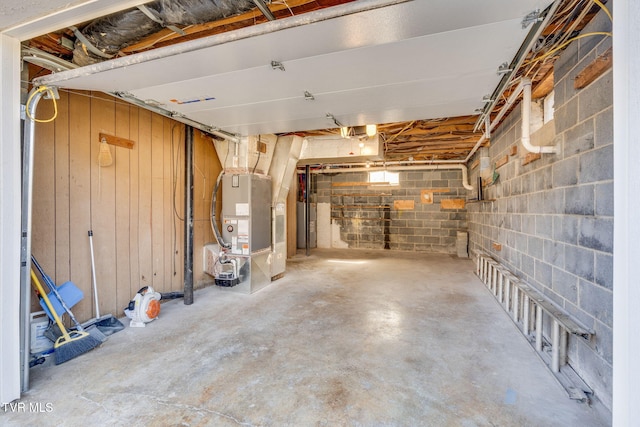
0,250 -> 610,426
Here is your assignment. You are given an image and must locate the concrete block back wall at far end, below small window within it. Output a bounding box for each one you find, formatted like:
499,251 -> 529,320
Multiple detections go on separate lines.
315,170 -> 468,254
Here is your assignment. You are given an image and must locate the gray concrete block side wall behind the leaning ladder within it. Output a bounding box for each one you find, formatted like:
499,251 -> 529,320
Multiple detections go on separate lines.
468,6 -> 613,409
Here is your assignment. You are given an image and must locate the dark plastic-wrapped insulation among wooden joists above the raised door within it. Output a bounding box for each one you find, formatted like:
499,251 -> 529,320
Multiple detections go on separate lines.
73,0 -> 255,66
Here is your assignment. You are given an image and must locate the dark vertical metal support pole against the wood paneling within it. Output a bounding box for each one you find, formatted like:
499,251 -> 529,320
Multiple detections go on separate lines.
184,126 -> 193,305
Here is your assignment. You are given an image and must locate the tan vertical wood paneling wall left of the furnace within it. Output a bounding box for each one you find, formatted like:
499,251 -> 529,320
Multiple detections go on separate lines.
32,90 -> 221,321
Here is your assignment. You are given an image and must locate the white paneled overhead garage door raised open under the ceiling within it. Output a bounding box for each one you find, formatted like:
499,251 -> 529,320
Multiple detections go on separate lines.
40,0 -> 549,135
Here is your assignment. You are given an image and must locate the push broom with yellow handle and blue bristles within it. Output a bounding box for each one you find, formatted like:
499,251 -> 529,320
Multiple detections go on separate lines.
31,269 -> 100,365
